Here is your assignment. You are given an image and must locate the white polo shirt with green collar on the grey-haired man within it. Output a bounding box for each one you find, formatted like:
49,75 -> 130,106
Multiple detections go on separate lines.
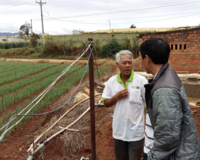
102,72 -> 147,142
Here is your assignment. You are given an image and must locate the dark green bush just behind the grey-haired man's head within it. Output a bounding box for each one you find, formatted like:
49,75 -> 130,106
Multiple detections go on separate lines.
101,38 -> 123,59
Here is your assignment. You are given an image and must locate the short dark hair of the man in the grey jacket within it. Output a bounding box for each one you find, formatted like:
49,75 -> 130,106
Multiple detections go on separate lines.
140,37 -> 170,64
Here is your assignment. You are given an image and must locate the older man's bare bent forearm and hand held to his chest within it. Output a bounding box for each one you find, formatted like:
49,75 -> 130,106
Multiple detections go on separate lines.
104,89 -> 128,108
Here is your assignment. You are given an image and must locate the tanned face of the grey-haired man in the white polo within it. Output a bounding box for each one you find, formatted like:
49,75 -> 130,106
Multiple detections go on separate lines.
116,55 -> 133,75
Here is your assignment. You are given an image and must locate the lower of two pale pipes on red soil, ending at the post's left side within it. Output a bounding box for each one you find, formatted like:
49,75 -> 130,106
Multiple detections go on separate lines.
27,107 -> 90,160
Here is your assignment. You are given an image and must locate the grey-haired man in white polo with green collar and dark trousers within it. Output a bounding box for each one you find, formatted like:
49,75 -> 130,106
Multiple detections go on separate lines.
102,50 -> 147,160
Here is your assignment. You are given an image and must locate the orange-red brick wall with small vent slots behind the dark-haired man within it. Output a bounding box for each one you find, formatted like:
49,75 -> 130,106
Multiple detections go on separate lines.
139,29 -> 200,73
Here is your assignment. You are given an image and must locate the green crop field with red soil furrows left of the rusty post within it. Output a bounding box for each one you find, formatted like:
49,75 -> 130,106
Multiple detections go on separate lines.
0,62 -> 111,142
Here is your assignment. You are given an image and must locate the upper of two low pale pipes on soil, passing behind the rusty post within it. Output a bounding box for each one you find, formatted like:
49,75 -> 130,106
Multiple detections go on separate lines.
27,93 -> 101,152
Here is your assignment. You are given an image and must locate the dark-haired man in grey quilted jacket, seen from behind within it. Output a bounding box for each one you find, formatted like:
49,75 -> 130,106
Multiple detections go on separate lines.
140,37 -> 199,160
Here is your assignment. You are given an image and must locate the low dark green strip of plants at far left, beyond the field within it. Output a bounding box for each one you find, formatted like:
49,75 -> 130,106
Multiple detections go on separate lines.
0,42 -> 29,49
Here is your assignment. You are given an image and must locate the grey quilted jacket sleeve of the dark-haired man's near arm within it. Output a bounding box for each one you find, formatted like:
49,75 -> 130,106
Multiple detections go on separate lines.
148,88 -> 183,160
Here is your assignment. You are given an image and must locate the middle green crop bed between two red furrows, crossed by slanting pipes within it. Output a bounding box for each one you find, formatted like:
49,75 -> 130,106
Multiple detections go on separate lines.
0,65 -> 81,112
